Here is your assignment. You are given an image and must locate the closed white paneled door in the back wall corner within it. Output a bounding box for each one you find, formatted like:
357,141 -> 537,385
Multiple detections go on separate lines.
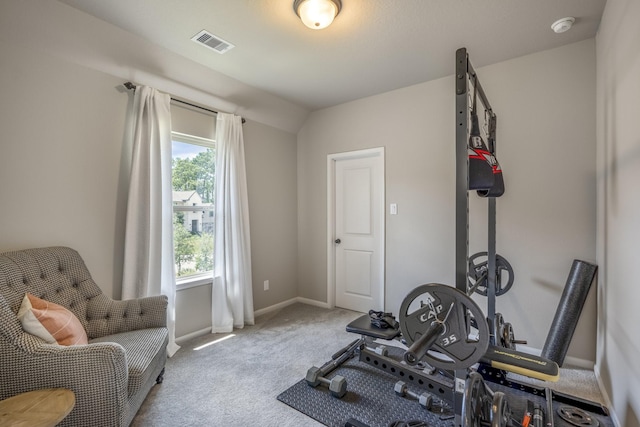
329,149 -> 385,313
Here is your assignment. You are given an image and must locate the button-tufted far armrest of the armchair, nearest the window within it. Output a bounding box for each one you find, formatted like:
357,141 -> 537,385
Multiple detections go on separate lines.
87,295 -> 168,339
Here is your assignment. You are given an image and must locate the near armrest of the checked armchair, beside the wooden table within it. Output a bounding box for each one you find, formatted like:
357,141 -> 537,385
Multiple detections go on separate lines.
0,333 -> 128,425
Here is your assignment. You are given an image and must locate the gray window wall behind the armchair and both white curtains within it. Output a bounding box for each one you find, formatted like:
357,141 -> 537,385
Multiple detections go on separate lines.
0,35 -> 297,336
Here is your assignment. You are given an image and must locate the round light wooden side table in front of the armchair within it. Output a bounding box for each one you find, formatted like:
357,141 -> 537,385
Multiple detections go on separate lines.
0,388 -> 76,427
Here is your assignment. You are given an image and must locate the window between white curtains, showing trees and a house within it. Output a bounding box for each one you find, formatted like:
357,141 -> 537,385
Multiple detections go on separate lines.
171,132 -> 215,283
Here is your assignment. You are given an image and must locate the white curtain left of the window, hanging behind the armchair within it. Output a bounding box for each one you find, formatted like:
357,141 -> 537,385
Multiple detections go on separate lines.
122,86 -> 180,356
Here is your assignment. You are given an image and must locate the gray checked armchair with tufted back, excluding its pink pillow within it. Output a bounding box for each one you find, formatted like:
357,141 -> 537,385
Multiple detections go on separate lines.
0,247 -> 167,426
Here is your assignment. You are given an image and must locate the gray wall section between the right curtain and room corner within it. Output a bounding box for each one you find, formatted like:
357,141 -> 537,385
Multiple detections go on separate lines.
244,121 -> 298,310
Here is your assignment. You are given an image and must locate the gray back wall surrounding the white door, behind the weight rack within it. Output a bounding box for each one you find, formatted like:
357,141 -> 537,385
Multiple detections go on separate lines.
298,39 -> 596,362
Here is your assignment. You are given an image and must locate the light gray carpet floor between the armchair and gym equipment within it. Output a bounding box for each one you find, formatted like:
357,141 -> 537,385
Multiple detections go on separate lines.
131,304 -> 602,427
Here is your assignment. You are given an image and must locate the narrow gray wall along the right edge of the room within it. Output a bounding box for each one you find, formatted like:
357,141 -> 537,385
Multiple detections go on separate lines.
596,0 -> 640,427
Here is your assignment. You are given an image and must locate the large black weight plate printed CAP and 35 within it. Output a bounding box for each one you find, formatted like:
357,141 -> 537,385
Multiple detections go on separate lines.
399,283 -> 489,370
